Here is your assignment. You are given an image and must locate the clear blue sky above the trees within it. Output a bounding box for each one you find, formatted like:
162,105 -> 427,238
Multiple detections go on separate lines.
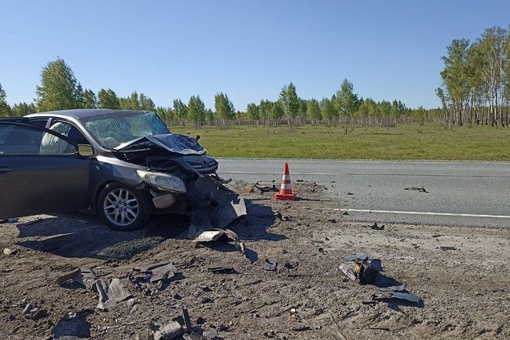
0,0 -> 510,110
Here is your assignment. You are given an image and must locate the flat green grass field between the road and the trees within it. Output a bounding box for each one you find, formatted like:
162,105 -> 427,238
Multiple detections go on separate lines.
170,124 -> 510,161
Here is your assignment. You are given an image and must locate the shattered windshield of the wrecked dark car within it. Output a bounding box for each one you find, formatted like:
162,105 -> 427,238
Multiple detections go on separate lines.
85,111 -> 170,149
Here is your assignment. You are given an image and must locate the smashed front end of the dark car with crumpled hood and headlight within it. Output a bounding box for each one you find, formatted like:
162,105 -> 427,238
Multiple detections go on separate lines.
114,134 -> 246,234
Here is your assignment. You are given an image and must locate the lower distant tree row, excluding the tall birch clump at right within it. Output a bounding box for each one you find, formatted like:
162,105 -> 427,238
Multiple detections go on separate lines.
0,58 -> 430,131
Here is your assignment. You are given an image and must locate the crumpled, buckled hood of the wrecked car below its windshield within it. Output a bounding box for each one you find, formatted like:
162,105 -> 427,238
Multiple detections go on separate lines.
118,133 -> 207,155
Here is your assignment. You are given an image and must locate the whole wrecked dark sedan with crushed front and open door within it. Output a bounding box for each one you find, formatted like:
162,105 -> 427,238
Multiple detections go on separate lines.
0,109 -> 246,232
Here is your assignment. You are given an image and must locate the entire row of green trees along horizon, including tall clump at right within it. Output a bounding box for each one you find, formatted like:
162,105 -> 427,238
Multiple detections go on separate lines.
0,40 -> 510,132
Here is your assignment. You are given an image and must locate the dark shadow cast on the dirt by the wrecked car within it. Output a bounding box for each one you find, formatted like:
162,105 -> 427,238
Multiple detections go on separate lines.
16,200 -> 287,261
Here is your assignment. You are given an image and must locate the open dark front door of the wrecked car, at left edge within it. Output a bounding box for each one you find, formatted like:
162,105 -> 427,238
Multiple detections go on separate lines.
0,120 -> 90,219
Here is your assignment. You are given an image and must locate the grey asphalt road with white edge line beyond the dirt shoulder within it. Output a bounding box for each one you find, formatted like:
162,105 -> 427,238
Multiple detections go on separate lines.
218,158 -> 510,227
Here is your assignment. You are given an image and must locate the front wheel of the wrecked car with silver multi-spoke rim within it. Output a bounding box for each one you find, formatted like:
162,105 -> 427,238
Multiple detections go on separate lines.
97,182 -> 152,231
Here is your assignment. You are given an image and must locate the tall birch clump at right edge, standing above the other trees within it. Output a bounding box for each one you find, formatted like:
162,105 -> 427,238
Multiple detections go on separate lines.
436,27 -> 510,126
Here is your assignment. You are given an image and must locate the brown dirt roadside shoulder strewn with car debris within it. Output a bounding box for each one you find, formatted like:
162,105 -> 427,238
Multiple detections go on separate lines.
0,183 -> 510,339
